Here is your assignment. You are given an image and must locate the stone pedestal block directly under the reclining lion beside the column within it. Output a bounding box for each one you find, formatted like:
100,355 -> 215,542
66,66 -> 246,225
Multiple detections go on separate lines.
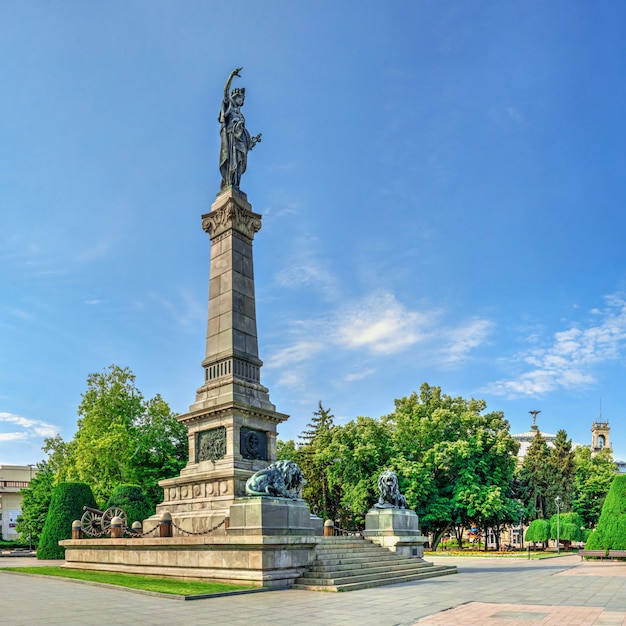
226,497 -> 316,536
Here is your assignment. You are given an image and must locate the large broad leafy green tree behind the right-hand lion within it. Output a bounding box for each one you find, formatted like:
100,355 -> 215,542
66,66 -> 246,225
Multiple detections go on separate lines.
383,383 -> 519,547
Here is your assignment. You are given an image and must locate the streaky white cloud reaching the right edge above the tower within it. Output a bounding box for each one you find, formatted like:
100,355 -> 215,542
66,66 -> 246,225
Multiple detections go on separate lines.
485,294 -> 626,397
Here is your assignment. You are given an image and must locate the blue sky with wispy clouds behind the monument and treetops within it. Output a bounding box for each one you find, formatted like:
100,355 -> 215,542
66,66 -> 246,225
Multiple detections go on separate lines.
0,0 -> 626,464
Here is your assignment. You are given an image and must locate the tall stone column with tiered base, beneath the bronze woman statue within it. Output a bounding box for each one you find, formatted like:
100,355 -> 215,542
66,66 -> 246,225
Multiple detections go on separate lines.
157,187 -> 288,531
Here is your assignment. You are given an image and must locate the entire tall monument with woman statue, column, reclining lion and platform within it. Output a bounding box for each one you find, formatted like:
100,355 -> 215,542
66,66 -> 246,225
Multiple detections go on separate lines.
62,68 -> 322,587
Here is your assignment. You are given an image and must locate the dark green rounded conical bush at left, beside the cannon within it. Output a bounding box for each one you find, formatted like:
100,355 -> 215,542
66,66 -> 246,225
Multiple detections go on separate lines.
37,483 -> 96,559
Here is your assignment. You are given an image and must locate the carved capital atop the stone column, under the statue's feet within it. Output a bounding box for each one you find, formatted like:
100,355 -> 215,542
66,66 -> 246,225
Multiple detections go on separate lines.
202,188 -> 261,240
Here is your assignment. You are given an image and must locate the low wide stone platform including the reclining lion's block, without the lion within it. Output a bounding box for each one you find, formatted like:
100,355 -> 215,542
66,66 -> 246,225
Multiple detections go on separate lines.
60,497 -> 322,588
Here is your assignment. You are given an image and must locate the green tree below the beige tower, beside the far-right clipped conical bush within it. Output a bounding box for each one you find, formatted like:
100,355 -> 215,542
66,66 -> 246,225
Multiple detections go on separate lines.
572,446 -> 616,528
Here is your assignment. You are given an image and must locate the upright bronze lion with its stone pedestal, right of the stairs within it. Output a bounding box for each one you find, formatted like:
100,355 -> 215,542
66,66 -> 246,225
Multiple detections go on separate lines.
363,470 -> 428,559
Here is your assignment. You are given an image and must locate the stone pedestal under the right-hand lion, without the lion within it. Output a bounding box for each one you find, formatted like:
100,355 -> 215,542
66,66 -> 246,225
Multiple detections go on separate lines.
363,508 -> 428,559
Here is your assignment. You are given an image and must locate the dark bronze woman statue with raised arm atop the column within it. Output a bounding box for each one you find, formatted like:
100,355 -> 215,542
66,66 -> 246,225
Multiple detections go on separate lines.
218,67 -> 261,189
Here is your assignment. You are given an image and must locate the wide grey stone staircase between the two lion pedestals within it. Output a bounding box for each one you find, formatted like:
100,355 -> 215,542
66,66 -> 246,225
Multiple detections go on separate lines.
292,536 -> 457,591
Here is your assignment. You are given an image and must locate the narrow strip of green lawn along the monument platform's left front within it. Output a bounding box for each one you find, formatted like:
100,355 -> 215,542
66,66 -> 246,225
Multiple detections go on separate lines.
3,566 -> 258,596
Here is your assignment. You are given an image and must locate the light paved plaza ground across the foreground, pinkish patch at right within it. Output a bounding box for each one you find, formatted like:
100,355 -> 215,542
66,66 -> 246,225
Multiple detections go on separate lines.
0,556 -> 626,626
